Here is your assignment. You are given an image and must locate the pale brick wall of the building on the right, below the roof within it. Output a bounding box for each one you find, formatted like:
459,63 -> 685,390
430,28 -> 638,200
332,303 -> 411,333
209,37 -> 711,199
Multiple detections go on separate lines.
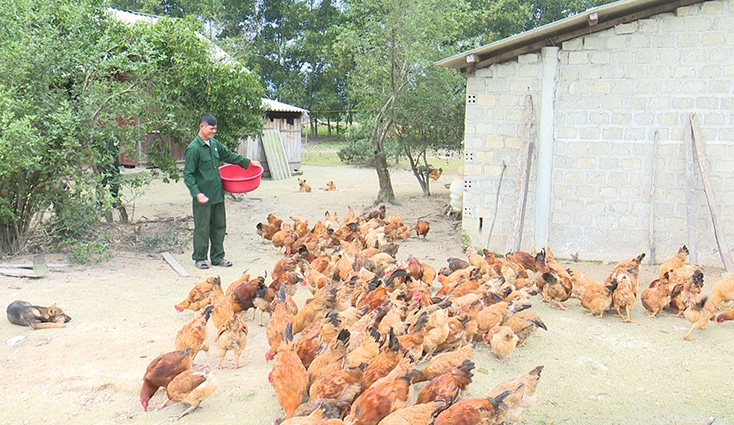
463,0 -> 734,266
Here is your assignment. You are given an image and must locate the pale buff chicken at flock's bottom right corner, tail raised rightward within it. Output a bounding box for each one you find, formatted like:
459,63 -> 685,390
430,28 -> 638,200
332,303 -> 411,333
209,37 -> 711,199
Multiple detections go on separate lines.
487,365 -> 543,424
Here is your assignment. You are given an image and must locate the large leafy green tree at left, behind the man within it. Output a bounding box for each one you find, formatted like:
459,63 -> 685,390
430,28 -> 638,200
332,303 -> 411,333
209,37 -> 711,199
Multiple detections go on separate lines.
0,0 -> 262,254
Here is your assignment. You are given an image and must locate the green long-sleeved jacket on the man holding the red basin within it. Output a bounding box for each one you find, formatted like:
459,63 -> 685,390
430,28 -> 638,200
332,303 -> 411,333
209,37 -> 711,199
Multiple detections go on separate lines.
184,135 -> 250,205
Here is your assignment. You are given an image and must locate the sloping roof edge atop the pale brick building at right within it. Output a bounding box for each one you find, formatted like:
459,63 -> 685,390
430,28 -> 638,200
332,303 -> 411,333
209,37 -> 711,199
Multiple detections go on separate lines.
436,0 -> 704,72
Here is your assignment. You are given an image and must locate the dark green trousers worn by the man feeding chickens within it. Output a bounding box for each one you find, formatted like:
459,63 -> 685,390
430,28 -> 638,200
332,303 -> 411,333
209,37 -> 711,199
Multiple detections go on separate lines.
191,198 -> 227,264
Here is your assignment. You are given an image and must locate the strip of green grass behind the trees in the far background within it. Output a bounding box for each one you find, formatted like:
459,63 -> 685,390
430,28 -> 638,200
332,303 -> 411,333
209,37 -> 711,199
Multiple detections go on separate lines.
301,140 -> 464,174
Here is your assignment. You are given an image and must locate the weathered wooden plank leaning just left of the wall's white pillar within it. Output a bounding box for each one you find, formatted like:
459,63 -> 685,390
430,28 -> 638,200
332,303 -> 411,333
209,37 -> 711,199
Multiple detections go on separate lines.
507,94 -> 534,252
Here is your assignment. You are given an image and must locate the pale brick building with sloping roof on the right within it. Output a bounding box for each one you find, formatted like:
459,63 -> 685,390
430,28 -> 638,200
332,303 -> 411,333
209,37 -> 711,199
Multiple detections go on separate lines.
438,0 -> 734,271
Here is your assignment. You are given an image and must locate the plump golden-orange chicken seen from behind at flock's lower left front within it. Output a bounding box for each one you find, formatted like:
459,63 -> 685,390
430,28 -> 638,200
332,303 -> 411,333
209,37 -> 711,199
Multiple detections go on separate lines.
268,323 -> 308,419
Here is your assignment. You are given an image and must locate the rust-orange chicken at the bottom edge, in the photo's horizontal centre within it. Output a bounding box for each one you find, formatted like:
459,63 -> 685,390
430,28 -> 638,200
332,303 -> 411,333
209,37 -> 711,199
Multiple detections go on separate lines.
344,371 -> 419,425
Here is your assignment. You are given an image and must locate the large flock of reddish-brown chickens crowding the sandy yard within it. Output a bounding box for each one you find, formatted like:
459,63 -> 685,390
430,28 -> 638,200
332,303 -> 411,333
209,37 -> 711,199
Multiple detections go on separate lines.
140,206 -> 734,425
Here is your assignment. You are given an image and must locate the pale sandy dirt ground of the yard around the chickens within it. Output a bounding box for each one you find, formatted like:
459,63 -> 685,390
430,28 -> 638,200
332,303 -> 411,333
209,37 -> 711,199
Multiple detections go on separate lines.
0,166 -> 734,425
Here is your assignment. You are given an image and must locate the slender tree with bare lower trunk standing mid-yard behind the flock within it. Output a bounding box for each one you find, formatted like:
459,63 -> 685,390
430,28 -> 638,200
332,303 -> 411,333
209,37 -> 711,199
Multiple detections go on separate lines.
340,0 -> 463,202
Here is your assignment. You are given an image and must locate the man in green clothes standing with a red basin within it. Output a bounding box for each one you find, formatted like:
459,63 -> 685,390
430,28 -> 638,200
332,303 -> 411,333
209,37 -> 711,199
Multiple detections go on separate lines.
184,114 -> 260,269
